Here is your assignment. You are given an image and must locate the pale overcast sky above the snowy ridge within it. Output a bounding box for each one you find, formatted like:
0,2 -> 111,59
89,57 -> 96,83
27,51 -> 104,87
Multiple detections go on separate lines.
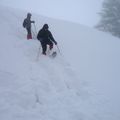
0,0 -> 103,27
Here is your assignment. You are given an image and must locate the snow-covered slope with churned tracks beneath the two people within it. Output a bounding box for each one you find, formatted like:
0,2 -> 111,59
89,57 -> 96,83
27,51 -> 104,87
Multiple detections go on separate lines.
0,6 -> 120,120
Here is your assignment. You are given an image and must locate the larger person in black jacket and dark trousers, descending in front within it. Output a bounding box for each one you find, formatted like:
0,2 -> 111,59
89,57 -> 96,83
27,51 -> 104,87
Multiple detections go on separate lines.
37,24 -> 57,55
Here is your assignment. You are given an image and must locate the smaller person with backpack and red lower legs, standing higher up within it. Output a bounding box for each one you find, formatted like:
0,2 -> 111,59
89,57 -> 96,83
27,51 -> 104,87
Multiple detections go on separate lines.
23,13 -> 35,40
